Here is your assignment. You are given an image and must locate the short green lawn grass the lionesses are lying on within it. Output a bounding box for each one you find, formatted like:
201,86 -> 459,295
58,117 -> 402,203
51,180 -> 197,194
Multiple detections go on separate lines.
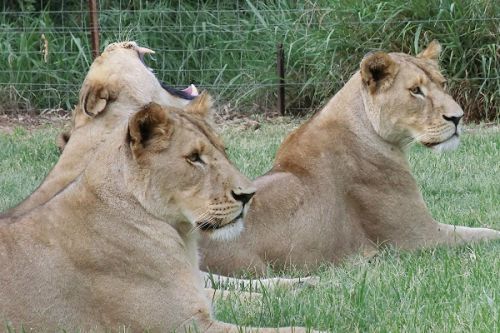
0,120 -> 500,333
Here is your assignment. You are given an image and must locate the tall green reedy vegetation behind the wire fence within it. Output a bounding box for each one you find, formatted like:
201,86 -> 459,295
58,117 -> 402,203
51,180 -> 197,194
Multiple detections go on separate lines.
0,0 -> 500,122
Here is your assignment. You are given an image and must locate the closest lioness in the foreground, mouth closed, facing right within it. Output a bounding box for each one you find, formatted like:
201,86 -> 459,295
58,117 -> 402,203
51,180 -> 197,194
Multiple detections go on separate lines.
0,94 -> 312,332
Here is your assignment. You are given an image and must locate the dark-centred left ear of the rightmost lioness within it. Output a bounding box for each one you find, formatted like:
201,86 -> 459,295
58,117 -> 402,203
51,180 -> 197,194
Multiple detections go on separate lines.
360,51 -> 399,94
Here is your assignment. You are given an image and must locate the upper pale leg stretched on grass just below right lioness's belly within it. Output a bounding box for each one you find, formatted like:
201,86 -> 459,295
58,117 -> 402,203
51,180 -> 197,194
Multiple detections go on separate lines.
202,272 -> 319,290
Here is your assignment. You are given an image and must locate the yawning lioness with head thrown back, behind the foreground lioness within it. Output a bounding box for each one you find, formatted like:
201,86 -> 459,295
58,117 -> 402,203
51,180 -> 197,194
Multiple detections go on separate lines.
0,42 -> 196,217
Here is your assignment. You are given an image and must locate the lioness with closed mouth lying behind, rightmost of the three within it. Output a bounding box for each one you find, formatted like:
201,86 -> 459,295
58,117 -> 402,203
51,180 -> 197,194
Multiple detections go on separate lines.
201,41 -> 500,274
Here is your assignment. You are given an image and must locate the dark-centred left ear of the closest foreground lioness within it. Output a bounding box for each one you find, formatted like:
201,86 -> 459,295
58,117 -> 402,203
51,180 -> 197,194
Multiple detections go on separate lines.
128,103 -> 173,158
